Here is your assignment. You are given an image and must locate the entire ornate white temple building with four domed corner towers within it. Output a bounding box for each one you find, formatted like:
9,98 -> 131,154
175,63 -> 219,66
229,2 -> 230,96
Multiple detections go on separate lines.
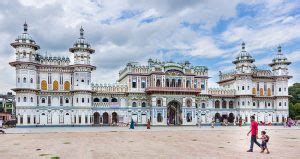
9,23 -> 291,126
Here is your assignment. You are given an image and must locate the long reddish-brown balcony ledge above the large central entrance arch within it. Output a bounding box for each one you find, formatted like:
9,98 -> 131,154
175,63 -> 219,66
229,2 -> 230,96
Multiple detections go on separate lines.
146,87 -> 201,94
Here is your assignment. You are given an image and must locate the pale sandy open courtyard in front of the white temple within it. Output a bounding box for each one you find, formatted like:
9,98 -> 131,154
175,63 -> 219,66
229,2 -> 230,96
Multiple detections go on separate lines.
0,126 -> 300,159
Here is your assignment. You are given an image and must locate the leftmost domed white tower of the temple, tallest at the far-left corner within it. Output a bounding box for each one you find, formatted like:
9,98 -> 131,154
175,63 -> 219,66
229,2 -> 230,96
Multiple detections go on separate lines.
9,22 -> 40,125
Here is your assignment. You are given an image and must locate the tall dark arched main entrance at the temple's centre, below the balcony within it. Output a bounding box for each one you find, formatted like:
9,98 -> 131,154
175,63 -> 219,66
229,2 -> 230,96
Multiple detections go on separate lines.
167,101 -> 182,125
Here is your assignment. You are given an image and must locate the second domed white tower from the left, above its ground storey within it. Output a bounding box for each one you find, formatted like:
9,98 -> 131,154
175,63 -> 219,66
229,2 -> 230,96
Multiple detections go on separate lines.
69,27 -> 96,106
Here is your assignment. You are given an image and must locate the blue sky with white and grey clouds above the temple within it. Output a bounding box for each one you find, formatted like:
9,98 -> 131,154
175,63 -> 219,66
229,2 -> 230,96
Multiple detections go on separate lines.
0,0 -> 300,93
